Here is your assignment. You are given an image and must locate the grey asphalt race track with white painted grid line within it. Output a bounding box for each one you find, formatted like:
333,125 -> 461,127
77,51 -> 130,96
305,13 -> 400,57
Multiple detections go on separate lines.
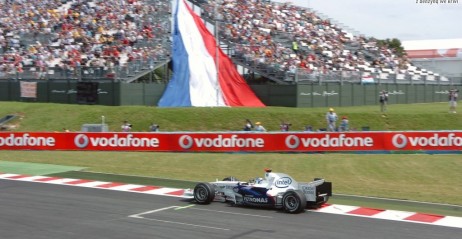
0,180 -> 462,239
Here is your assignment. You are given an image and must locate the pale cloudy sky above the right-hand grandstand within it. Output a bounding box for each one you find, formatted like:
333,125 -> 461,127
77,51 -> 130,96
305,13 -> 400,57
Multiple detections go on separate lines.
273,0 -> 462,41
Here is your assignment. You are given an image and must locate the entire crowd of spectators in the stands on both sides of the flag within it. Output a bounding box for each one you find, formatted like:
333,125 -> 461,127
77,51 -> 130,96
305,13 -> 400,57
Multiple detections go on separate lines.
0,0 -> 444,83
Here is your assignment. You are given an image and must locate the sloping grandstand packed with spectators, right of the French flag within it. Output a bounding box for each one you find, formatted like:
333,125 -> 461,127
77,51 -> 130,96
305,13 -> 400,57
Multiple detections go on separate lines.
197,0 -> 451,84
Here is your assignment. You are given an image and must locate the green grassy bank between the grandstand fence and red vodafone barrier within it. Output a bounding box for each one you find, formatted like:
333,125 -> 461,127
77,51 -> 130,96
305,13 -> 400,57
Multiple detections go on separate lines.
0,102 -> 462,132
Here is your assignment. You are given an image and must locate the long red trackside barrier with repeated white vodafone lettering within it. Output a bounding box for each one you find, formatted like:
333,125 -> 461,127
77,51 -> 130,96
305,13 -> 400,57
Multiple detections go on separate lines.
0,131 -> 462,152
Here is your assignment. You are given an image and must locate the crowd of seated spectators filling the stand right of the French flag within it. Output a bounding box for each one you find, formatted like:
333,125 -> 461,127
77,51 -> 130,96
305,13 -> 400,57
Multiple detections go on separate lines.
201,0 -> 440,82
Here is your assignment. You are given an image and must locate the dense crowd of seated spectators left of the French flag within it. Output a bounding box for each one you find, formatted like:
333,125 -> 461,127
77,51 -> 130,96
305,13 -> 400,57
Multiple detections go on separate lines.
0,0 -> 171,78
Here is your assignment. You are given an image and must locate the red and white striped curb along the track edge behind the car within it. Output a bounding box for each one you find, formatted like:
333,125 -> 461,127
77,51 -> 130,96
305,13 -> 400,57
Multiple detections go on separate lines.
0,173 -> 462,228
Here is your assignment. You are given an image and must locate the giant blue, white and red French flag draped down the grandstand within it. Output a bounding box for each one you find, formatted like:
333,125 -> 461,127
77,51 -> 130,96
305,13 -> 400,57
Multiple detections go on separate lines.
158,0 -> 265,107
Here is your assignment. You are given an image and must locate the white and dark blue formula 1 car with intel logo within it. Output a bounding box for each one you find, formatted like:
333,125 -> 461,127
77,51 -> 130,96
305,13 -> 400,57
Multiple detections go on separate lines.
183,169 -> 332,213
